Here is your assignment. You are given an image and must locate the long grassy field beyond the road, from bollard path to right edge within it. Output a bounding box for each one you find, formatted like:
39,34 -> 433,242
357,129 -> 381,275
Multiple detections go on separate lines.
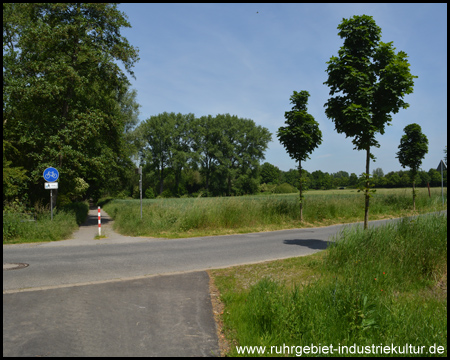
103,188 -> 446,238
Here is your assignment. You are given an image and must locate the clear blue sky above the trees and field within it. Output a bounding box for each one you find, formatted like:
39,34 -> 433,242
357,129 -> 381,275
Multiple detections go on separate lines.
118,3 -> 447,175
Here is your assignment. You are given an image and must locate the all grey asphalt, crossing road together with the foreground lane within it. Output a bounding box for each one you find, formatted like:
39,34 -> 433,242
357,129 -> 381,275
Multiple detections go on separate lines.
3,210 -> 446,356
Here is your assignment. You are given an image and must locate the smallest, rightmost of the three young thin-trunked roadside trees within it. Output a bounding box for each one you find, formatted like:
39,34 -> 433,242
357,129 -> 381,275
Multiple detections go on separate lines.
396,124 -> 428,210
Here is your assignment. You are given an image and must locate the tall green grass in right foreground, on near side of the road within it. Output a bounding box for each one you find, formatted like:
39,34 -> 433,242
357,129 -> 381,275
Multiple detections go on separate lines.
214,216 -> 447,356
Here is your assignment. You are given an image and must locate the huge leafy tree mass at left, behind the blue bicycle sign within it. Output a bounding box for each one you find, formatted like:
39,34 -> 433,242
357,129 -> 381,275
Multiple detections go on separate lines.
3,3 -> 138,204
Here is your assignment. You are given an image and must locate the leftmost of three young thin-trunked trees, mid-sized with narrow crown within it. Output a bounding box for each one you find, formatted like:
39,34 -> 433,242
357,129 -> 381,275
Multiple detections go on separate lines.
277,90 -> 322,221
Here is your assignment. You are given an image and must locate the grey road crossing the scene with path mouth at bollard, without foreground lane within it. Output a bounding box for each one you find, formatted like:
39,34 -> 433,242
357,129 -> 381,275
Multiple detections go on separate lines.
3,210 -> 422,293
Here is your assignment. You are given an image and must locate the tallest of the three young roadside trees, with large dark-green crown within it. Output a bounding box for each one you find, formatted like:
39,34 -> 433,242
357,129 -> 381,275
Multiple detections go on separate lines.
324,15 -> 417,229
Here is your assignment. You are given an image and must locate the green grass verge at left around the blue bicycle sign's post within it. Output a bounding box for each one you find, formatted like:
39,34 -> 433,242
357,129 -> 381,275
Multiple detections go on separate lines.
3,202 -> 89,244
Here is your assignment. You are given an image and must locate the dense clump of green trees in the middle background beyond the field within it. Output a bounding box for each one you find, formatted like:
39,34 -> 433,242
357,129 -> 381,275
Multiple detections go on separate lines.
136,113 -> 271,196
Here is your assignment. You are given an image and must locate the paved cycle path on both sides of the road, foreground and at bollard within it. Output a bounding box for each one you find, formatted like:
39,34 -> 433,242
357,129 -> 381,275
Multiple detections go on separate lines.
3,208 -> 220,357
